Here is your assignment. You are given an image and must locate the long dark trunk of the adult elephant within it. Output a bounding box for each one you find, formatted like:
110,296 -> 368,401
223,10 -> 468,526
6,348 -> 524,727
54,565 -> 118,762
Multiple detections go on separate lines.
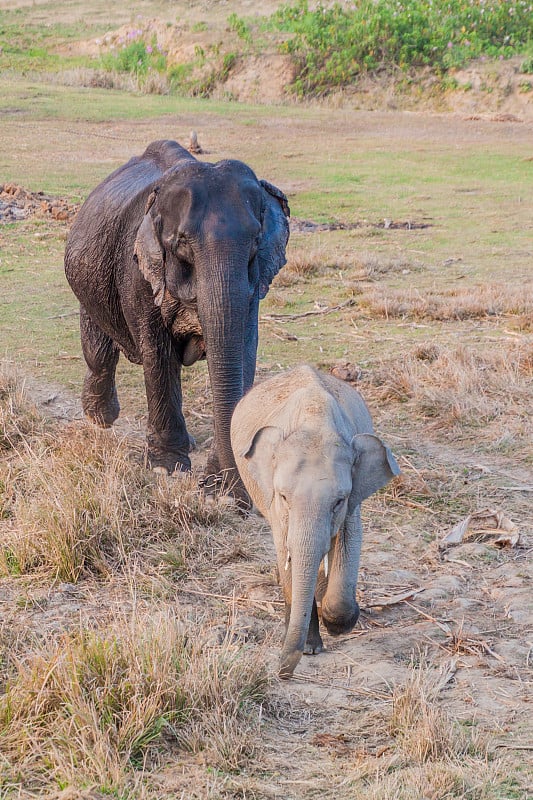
198,253 -> 251,498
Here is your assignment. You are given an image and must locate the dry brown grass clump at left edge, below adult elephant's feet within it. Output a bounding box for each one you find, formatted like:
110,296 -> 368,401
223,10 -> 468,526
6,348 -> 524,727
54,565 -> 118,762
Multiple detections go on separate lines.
0,425 -> 239,582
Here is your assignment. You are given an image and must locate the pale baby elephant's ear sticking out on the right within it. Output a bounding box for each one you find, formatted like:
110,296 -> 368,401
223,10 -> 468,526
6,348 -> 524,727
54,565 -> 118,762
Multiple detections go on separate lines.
349,433 -> 400,508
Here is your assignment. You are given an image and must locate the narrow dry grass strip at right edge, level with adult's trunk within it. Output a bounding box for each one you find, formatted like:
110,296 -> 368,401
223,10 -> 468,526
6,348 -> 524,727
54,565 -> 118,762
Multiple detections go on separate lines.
357,284 -> 533,322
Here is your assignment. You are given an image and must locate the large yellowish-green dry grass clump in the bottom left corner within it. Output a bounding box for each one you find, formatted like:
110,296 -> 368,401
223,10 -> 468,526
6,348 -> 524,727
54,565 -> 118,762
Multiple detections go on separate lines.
0,609 -> 267,796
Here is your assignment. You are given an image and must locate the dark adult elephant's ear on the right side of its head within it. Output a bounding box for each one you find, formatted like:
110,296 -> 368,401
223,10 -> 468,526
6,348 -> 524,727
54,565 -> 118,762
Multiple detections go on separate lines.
257,181 -> 291,299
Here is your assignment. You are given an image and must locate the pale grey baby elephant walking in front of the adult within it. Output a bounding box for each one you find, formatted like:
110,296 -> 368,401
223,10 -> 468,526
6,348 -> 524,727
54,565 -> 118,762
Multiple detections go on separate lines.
231,365 -> 400,678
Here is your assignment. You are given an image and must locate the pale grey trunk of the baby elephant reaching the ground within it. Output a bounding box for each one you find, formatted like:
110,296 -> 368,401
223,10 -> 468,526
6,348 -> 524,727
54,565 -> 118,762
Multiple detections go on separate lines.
279,523 -> 329,678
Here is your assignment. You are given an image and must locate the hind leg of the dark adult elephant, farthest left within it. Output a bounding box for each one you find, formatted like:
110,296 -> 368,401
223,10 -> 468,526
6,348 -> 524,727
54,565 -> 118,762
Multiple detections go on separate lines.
80,306 -> 120,428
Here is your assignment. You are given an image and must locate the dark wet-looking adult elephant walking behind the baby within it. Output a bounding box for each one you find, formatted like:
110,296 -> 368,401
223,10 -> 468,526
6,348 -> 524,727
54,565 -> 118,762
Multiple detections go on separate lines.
65,141 -> 289,494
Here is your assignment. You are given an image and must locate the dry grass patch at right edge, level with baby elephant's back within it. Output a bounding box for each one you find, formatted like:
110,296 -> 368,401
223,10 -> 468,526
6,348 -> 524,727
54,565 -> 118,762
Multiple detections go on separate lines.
370,342 -> 533,437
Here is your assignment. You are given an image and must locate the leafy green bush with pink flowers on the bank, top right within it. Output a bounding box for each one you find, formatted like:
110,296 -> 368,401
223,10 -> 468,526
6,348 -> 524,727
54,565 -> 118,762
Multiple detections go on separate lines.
268,0 -> 533,94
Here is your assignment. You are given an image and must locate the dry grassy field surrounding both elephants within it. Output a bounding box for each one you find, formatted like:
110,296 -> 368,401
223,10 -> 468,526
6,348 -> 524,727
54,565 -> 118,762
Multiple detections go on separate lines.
0,2 -> 533,800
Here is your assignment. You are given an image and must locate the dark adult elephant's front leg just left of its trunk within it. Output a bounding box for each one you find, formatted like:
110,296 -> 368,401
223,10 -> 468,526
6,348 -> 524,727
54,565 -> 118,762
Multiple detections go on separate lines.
143,342 -> 191,474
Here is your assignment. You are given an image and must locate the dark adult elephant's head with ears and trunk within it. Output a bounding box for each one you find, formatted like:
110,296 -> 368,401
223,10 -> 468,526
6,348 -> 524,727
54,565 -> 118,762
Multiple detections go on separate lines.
135,159 -> 289,490
